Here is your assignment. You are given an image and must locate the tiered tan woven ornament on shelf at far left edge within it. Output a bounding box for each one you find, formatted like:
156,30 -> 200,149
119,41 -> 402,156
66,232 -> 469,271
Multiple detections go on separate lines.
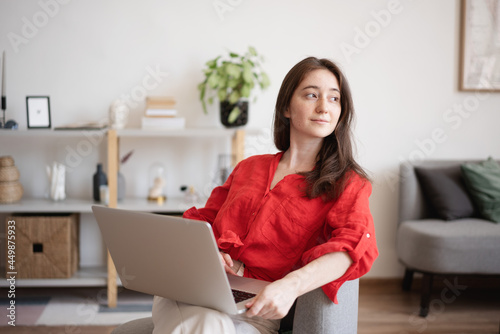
0,156 -> 24,204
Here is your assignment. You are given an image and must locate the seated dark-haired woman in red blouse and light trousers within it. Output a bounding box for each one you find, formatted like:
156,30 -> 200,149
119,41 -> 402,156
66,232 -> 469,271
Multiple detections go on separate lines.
153,57 -> 378,333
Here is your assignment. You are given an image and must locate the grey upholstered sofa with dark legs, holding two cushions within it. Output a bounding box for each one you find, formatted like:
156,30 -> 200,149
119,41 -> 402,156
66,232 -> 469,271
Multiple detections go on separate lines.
396,160 -> 500,317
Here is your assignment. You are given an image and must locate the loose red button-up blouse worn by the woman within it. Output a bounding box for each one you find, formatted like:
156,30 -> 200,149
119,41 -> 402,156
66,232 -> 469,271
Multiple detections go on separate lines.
184,152 -> 378,303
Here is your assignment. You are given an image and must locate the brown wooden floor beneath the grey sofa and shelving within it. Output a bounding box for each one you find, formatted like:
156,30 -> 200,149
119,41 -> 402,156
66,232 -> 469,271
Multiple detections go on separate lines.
0,277 -> 500,334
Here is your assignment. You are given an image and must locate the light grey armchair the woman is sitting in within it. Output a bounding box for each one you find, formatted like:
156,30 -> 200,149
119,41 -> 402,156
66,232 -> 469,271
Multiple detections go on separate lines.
112,279 -> 359,334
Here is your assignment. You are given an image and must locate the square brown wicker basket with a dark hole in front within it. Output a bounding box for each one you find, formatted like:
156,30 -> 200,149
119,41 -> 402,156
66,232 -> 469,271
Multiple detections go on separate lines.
6,214 -> 79,278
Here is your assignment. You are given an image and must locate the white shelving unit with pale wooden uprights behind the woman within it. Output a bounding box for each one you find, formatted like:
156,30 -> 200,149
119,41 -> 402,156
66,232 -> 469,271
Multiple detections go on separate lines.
0,128 -> 249,307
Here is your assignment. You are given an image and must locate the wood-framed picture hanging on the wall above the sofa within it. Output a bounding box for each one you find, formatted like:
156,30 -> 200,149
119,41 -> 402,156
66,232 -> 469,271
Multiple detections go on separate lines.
459,0 -> 500,92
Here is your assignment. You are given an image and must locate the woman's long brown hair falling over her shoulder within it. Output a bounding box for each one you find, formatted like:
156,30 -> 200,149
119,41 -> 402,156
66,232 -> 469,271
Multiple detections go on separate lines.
274,57 -> 369,200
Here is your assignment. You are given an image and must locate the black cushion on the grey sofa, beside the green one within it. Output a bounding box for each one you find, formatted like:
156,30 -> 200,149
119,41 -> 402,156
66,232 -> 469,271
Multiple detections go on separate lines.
415,166 -> 474,220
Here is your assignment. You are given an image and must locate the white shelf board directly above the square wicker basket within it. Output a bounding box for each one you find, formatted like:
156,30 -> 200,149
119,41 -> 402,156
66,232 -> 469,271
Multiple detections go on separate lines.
0,198 -> 96,213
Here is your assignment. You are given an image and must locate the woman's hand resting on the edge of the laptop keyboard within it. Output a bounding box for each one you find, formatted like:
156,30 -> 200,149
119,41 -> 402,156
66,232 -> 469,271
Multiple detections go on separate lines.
245,278 -> 298,319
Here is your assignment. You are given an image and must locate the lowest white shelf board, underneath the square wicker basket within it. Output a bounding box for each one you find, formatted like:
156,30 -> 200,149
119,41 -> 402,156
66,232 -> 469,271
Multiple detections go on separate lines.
0,267 -> 121,288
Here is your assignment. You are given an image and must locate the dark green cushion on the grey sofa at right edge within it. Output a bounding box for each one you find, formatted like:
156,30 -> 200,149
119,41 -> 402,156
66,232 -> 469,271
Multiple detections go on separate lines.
461,158 -> 500,223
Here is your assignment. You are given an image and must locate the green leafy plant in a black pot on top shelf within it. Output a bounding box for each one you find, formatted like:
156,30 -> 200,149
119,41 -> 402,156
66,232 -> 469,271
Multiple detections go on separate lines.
198,47 -> 270,127
